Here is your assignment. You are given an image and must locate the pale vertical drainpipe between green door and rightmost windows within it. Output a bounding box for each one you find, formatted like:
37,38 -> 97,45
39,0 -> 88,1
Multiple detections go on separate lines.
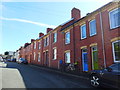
100,11 -> 106,68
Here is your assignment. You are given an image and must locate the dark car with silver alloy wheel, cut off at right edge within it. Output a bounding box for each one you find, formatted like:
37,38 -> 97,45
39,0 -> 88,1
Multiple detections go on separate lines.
89,63 -> 120,88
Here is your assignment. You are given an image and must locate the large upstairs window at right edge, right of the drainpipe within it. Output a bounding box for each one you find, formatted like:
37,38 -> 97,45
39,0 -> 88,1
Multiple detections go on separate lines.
109,8 -> 120,29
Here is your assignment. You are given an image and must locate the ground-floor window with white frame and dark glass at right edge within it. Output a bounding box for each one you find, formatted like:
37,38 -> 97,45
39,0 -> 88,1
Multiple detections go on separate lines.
112,40 -> 120,62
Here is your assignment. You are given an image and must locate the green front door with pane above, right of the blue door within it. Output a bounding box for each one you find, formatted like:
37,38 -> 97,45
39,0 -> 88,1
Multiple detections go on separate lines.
92,46 -> 99,70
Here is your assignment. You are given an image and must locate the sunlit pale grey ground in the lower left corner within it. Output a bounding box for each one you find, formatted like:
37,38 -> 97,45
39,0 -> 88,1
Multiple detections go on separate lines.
0,62 -> 25,90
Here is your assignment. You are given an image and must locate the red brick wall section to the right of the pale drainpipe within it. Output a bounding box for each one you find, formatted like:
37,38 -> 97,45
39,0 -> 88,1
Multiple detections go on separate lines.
102,10 -> 120,66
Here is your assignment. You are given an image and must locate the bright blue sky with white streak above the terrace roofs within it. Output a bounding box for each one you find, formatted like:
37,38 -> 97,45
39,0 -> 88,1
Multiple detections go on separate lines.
0,0 -> 111,54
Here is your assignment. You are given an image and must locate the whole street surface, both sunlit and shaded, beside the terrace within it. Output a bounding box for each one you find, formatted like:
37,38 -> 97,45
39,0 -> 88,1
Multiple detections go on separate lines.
0,62 -> 91,88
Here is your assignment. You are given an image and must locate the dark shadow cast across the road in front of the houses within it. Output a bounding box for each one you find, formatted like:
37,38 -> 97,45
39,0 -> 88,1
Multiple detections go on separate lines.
3,62 -> 92,88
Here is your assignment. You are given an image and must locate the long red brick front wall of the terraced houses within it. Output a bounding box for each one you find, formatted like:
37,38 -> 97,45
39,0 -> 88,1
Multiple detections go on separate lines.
20,2 -> 120,71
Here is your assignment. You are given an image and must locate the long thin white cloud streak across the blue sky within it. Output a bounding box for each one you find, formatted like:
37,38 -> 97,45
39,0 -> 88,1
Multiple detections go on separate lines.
0,17 -> 56,28
